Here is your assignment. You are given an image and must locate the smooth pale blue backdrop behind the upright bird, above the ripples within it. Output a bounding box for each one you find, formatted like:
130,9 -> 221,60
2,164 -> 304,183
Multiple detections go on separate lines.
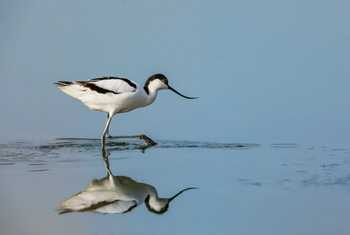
0,0 -> 350,144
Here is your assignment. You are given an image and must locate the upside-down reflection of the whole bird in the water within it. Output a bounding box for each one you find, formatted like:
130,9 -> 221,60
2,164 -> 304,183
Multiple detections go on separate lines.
58,145 -> 195,214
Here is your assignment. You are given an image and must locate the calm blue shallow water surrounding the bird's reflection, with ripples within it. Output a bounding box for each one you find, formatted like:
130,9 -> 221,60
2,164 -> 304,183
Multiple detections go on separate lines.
0,138 -> 350,235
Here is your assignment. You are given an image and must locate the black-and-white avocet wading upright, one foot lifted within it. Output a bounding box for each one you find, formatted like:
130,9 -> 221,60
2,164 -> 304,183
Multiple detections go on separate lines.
55,73 -> 197,145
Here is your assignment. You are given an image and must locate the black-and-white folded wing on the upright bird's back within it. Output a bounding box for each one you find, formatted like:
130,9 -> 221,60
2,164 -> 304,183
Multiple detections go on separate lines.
77,77 -> 137,94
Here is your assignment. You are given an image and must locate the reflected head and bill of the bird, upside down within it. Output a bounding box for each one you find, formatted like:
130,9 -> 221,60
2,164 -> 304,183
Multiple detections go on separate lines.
145,187 -> 197,214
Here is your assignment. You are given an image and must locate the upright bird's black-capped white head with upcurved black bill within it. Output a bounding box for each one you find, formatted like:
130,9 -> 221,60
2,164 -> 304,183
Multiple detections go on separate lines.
144,73 -> 198,99
